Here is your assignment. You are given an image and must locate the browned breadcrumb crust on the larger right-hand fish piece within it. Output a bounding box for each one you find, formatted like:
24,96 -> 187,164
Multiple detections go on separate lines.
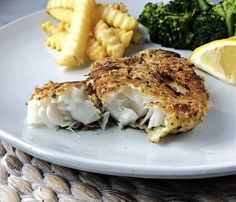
88,49 -> 209,142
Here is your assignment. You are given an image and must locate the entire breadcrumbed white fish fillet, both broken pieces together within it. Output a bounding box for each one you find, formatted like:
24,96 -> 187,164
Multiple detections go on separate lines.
26,50 -> 209,142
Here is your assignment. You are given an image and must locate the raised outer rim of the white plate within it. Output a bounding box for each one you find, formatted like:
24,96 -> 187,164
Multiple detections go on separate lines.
0,10 -> 236,179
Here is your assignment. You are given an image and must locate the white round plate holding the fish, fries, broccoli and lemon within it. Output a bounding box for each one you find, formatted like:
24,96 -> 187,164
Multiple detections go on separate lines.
0,1 -> 236,178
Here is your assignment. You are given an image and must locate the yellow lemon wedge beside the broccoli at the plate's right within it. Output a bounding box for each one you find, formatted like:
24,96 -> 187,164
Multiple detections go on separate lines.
189,37 -> 236,85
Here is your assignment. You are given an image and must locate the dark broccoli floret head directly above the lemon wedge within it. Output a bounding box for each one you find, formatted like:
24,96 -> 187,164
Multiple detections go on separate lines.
191,9 -> 228,49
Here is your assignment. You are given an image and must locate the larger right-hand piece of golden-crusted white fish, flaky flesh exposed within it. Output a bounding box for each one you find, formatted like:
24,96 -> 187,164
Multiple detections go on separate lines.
87,50 -> 209,142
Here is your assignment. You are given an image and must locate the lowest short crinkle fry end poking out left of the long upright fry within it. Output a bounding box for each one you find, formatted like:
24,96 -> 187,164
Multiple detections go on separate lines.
45,31 -> 67,51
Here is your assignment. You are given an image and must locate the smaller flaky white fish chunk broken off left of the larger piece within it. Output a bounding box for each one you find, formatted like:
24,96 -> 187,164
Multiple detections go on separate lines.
26,81 -> 108,128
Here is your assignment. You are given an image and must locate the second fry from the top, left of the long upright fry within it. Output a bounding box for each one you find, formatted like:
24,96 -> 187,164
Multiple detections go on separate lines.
48,8 -> 73,23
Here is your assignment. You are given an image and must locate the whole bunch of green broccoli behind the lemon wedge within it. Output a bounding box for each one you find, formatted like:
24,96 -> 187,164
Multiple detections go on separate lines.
139,0 -> 236,49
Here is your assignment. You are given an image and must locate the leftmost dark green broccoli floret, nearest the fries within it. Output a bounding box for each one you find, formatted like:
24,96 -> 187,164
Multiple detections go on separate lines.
139,0 -> 197,49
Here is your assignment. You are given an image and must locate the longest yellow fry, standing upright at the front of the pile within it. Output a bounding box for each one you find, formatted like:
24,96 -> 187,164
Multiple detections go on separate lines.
57,0 -> 95,67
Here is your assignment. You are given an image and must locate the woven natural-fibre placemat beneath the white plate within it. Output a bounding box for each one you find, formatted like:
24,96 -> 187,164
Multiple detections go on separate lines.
0,142 -> 236,202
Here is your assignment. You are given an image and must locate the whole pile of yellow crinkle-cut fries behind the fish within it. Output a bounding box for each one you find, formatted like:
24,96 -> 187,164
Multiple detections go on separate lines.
41,0 -> 141,67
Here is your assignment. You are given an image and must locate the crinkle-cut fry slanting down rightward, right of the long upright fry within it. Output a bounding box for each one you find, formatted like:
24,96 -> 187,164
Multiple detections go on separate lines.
94,20 -> 125,56
